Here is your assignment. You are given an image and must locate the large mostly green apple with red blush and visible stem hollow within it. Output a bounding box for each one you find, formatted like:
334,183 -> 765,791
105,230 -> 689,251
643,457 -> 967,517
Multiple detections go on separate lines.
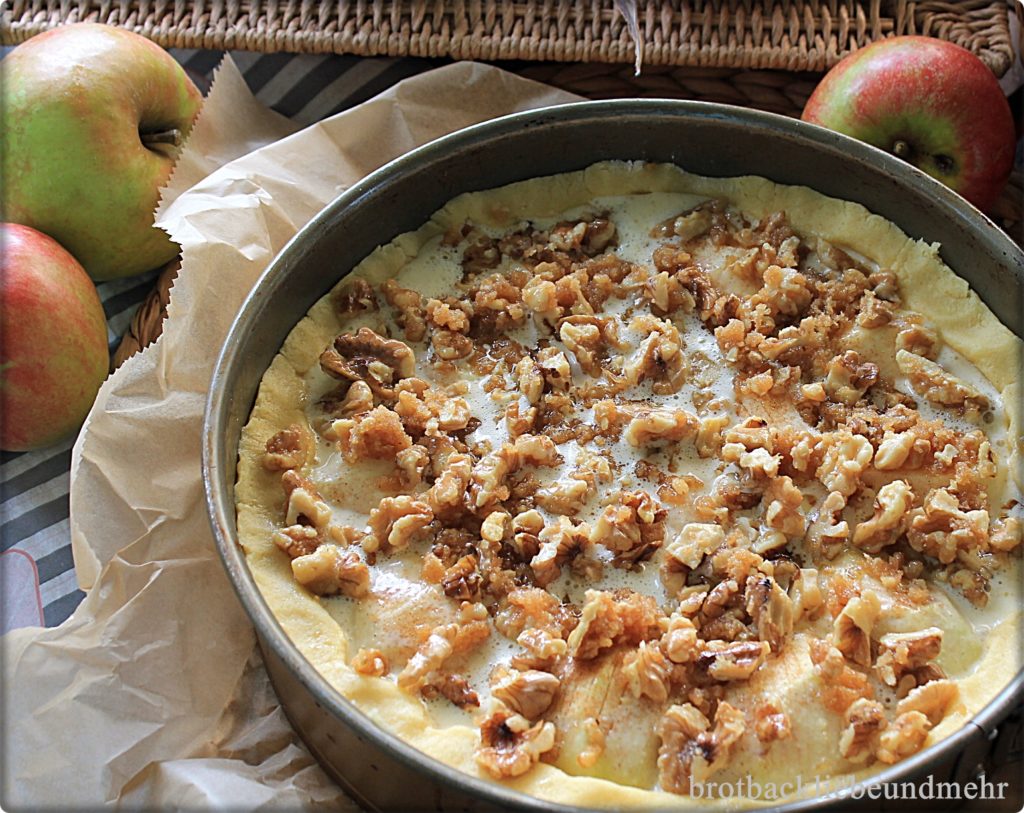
0,23 -> 202,280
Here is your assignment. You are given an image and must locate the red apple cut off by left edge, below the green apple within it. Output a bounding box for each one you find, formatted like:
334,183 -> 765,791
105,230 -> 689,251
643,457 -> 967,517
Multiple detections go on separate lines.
0,223 -> 109,452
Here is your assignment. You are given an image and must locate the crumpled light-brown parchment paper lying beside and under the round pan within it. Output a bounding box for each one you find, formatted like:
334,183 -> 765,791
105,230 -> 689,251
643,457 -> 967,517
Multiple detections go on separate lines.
2,59 -> 577,810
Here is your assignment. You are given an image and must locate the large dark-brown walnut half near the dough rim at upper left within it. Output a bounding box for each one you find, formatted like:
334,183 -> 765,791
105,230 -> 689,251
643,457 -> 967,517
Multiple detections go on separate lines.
319,328 -> 416,398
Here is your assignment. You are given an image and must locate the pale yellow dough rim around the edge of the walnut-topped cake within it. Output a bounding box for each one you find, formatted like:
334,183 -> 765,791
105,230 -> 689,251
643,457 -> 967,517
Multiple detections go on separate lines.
237,162 -> 1022,808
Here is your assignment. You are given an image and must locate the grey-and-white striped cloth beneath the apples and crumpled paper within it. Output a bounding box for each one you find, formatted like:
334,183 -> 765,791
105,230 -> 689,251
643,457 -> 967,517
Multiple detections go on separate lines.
0,48 -> 440,634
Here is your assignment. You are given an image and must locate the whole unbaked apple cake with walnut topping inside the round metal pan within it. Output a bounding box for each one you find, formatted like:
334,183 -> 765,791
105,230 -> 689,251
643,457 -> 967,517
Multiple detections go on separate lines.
237,162 -> 1022,806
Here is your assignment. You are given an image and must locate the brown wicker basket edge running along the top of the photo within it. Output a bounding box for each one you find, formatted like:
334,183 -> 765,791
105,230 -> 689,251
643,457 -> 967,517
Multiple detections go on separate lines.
0,0 -> 1013,76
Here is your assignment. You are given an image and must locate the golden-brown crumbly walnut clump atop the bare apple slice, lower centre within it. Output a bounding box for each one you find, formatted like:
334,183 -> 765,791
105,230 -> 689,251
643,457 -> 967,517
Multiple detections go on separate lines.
568,590 -> 660,660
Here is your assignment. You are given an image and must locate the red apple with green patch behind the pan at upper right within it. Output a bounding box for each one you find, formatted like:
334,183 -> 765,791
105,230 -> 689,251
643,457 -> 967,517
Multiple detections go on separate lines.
802,37 -> 1015,210
